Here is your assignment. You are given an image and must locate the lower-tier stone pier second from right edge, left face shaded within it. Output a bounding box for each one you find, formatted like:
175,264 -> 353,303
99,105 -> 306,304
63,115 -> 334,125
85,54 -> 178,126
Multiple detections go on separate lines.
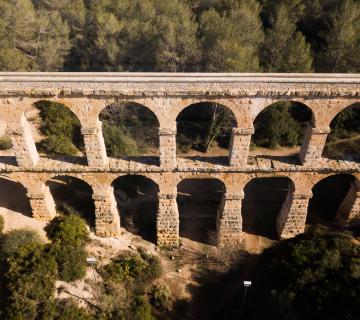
276,189 -> 312,239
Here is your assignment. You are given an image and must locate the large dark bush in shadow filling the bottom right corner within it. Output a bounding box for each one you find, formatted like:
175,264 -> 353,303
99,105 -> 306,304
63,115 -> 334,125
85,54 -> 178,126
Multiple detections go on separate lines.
233,227 -> 360,320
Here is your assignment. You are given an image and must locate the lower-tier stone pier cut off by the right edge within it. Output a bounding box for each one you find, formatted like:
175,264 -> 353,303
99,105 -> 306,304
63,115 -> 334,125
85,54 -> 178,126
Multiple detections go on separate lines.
336,181 -> 360,227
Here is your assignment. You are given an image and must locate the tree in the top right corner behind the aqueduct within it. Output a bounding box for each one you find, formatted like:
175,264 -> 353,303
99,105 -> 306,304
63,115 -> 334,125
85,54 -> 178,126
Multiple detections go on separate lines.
317,0 -> 360,72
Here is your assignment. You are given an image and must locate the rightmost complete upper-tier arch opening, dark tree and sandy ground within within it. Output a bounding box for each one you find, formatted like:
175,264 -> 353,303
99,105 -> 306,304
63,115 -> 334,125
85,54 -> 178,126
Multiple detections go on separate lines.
249,101 -> 313,162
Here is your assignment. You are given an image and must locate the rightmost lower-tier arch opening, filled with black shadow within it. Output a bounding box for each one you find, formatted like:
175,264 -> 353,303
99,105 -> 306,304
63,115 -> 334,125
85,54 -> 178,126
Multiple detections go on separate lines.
306,174 -> 355,227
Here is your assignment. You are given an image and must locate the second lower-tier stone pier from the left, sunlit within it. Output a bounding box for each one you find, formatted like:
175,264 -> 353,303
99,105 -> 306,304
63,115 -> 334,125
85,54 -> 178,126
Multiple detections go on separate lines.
92,186 -> 120,237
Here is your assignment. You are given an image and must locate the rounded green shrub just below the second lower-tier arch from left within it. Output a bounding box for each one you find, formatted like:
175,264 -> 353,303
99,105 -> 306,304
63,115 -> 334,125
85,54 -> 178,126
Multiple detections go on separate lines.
45,214 -> 88,246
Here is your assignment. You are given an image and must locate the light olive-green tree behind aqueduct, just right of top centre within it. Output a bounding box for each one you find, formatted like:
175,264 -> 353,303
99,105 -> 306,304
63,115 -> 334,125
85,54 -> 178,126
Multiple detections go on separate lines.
199,0 -> 263,72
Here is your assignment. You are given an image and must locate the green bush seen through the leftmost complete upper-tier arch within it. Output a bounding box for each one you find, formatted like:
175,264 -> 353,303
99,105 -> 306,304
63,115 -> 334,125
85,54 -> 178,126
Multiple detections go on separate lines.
35,101 -> 83,156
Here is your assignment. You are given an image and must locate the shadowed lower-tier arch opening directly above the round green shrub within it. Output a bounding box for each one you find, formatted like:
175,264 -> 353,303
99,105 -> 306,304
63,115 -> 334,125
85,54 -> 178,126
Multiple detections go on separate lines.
46,176 -> 95,232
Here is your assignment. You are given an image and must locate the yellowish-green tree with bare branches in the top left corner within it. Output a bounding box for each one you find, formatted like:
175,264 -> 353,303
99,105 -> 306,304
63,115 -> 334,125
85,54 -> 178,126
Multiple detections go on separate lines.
0,0 -> 70,71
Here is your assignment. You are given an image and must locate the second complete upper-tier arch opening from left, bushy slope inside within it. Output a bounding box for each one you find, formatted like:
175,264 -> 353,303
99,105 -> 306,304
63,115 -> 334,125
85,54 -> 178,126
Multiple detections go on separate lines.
99,102 -> 159,164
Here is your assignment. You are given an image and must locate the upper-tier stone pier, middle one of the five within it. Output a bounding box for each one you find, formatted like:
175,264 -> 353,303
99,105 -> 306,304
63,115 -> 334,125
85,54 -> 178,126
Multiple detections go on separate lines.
159,128 -> 176,170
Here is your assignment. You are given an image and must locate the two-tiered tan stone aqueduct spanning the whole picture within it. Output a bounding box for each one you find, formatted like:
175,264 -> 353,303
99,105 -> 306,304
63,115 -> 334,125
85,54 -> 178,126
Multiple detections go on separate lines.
0,73 -> 360,245
